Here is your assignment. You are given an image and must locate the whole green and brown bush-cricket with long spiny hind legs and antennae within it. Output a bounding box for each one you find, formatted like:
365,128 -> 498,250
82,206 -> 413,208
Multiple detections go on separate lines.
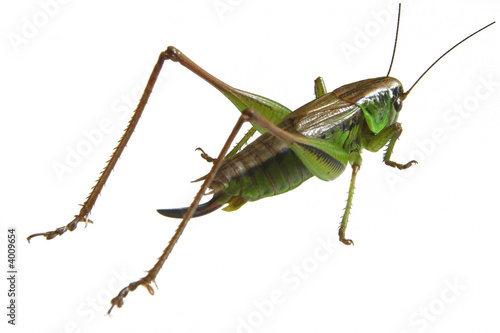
28,4 -> 495,314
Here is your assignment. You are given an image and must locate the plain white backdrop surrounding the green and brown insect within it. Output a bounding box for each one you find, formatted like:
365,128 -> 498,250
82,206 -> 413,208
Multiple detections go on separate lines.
0,0 -> 500,333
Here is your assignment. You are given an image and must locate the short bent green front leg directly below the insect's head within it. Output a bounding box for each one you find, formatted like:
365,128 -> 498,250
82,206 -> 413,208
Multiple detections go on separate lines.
361,123 -> 418,170
